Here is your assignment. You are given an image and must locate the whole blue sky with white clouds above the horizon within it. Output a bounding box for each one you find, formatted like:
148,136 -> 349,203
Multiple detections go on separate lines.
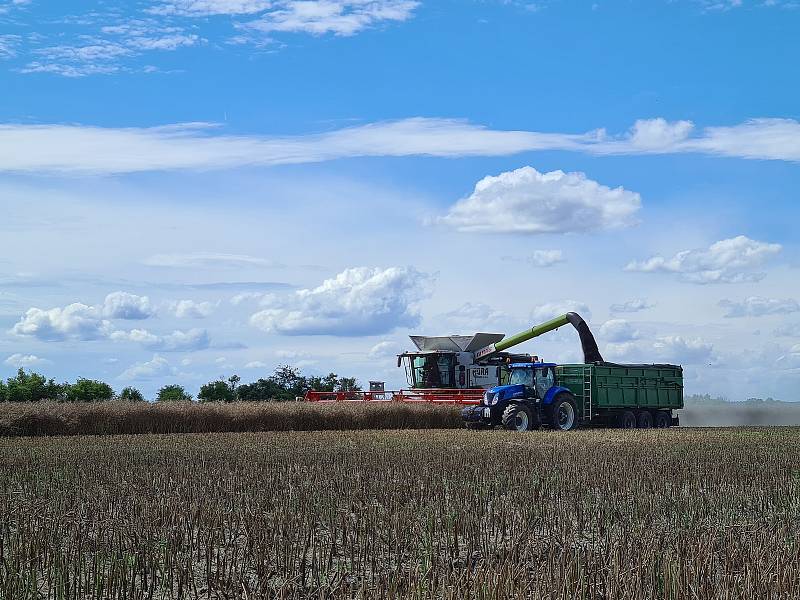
0,0 -> 800,400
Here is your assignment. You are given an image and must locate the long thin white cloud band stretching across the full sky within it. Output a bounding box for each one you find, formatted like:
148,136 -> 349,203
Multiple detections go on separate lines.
0,116 -> 800,173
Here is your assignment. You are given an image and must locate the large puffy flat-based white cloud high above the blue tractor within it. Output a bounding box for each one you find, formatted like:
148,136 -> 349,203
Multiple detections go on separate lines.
438,167 -> 641,234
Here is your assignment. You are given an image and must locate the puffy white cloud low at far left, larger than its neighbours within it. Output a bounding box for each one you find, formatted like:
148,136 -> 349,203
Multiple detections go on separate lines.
11,302 -> 111,341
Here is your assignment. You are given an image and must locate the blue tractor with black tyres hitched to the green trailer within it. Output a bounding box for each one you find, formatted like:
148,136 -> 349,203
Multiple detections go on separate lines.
461,362 -> 579,431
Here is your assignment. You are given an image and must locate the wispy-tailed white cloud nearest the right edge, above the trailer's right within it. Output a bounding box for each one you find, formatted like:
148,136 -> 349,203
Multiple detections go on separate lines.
625,235 -> 781,284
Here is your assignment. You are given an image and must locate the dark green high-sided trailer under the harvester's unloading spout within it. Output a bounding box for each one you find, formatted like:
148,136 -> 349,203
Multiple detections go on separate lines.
555,363 -> 683,428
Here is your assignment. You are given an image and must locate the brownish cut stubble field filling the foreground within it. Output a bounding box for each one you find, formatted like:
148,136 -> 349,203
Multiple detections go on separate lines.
0,428 -> 800,600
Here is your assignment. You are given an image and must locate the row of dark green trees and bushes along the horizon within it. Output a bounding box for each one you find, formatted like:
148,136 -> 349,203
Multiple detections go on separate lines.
0,365 -> 361,402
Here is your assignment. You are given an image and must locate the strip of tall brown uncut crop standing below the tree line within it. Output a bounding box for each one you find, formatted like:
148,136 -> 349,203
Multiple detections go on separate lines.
0,401 -> 464,436
